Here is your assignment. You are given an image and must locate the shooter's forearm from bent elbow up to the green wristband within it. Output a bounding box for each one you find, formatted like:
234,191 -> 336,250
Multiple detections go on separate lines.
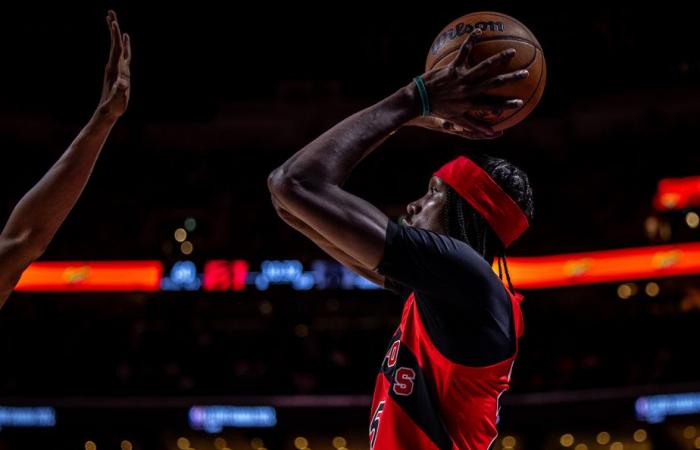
273,84 -> 418,186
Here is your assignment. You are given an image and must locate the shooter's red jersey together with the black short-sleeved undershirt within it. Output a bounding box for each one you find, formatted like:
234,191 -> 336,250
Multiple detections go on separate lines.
369,224 -> 523,450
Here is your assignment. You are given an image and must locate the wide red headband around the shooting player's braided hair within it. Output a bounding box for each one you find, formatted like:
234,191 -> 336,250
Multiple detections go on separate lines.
435,156 -> 529,247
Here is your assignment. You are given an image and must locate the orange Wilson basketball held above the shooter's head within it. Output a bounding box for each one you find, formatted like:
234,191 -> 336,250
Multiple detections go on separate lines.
425,12 -> 547,131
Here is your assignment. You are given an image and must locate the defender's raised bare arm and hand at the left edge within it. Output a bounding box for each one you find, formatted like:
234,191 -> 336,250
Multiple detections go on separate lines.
0,11 -> 131,307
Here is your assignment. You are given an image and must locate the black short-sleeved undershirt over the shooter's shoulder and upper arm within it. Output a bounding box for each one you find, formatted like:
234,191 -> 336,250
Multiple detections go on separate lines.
377,222 -> 515,366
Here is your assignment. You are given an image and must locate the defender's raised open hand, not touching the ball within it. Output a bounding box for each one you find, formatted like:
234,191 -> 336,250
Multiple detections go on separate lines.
98,11 -> 131,119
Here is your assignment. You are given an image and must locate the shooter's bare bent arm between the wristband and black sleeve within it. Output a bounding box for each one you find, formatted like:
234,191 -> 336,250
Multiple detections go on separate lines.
268,85 -> 418,270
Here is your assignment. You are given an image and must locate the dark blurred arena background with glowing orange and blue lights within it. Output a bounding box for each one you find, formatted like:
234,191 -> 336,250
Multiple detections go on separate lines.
0,1 -> 700,450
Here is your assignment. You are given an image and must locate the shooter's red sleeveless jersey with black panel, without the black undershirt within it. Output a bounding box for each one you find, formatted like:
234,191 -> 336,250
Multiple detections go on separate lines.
370,294 -> 523,450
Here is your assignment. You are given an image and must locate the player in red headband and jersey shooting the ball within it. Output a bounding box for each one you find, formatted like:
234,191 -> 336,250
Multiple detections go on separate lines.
268,30 -> 533,450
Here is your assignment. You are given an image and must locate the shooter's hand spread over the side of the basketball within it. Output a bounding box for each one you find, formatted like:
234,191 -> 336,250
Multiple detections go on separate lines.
422,28 -> 529,135
